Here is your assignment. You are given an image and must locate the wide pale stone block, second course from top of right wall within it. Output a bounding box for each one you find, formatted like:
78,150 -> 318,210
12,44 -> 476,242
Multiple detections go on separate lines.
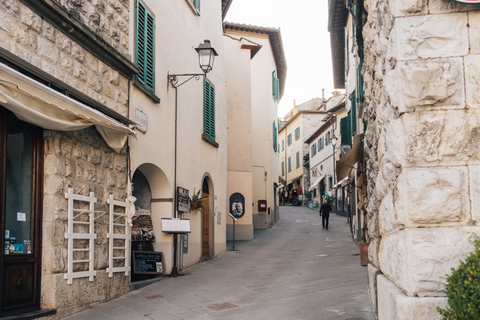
395,12 -> 469,60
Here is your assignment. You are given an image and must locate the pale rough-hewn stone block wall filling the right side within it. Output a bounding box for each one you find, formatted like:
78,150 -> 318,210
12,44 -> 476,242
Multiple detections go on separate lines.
363,0 -> 480,319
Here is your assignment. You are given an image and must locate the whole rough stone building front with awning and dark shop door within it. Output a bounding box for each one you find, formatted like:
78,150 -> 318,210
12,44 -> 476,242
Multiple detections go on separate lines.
0,0 -> 138,319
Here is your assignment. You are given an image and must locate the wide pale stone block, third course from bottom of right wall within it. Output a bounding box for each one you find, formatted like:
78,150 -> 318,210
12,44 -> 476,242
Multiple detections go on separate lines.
396,167 -> 470,227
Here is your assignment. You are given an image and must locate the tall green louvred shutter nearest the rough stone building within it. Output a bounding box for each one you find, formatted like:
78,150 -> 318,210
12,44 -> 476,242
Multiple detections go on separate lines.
135,1 -> 155,92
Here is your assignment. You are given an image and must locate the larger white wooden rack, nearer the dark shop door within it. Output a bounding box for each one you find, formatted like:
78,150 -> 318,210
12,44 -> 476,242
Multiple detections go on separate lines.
64,188 -> 105,284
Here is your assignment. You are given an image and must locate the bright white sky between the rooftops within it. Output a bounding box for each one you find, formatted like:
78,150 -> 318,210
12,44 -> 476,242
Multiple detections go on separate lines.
225,0 -> 334,117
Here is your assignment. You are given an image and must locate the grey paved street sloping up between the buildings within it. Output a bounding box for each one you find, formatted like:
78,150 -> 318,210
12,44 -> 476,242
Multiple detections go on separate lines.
64,207 -> 373,320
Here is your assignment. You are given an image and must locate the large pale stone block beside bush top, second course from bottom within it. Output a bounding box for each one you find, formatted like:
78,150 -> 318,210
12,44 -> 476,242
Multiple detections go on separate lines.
379,227 -> 480,297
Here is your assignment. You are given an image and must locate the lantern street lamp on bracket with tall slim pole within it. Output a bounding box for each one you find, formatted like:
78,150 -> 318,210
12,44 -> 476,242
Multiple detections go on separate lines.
167,40 -> 218,277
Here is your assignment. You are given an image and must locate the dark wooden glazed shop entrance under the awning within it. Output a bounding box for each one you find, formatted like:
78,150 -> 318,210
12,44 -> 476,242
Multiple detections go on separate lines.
0,107 -> 43,316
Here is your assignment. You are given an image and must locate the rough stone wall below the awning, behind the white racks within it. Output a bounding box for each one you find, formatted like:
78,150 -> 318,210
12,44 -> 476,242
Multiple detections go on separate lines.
41,127 -> 129,319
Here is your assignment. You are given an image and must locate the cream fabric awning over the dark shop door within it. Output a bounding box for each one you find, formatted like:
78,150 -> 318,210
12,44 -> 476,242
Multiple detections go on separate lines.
0,63 -> 135,152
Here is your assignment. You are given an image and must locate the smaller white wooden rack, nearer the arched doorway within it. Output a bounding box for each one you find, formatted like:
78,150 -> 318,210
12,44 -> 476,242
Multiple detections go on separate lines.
107,194 -> 131,277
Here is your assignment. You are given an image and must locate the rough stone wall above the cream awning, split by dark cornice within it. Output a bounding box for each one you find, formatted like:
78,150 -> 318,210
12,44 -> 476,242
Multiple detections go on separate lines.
0,0 -> 129,116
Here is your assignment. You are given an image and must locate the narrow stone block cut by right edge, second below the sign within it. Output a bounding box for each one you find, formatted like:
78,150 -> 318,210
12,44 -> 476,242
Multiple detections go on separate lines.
465,53 -> 480,108
